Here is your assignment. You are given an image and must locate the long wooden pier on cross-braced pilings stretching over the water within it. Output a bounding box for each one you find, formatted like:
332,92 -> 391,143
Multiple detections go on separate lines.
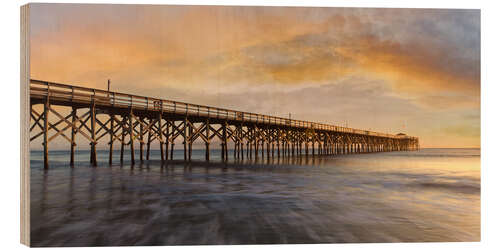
30,79 -> 419,169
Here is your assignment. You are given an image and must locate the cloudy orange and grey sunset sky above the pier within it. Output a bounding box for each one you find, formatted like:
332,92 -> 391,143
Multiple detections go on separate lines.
30,4 -> 481,147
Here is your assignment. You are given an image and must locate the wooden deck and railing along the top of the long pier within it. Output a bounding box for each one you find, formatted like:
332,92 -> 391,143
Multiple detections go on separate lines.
30,79 -> 416,139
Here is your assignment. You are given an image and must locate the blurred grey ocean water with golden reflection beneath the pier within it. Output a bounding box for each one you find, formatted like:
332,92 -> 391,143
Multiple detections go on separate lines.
31,149 -> 481,246
